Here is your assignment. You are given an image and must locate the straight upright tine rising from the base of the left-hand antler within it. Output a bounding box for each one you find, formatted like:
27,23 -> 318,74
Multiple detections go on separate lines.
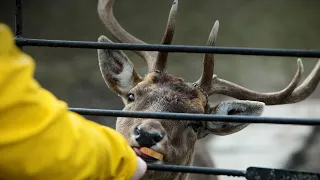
152,0 -> 178,71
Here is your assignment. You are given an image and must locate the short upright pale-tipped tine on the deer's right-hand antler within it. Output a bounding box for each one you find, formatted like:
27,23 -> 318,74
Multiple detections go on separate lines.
196,20 -> 219,91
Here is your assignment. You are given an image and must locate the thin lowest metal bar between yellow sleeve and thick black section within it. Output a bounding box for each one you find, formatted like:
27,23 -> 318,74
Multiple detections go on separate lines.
147,164 -> 246,177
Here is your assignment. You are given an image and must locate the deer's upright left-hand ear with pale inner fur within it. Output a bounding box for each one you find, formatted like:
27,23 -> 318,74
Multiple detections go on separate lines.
98,36 -> 142,96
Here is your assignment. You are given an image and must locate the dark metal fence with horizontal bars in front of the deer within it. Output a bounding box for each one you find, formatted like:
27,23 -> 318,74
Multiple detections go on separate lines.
15,0 -> 320,180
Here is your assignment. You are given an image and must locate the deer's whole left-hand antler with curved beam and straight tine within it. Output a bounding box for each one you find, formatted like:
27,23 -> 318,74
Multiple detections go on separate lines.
98,0 -> 178,72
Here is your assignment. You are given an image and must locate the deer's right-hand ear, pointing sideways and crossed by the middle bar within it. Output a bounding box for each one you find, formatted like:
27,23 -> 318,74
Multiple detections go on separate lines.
205,100 -> 265,136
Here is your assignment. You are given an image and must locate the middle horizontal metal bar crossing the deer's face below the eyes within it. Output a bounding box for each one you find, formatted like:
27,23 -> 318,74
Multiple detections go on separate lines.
69,108 -> 320,125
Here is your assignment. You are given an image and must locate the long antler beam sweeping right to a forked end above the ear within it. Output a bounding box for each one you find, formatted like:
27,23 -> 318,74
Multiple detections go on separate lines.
209,59 -> 312,105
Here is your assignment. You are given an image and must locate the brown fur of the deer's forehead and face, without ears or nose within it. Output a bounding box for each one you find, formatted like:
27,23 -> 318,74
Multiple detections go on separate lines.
107,72 -> 218,179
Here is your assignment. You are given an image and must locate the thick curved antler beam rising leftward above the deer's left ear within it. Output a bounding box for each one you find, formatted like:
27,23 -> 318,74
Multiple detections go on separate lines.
98,0 -> 157,70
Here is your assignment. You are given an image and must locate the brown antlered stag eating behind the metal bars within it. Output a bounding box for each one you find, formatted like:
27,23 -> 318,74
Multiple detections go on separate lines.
98,0 -> 320,180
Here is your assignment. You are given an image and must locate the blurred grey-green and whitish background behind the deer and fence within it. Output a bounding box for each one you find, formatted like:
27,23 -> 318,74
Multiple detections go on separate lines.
0,0 -> 320,179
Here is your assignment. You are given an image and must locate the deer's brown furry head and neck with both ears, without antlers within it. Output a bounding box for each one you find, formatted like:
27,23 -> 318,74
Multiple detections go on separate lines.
98,28 -> 264,180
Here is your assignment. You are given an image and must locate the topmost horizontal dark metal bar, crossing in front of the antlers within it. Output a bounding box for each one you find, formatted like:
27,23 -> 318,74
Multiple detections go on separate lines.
15,38 -> 320,58
